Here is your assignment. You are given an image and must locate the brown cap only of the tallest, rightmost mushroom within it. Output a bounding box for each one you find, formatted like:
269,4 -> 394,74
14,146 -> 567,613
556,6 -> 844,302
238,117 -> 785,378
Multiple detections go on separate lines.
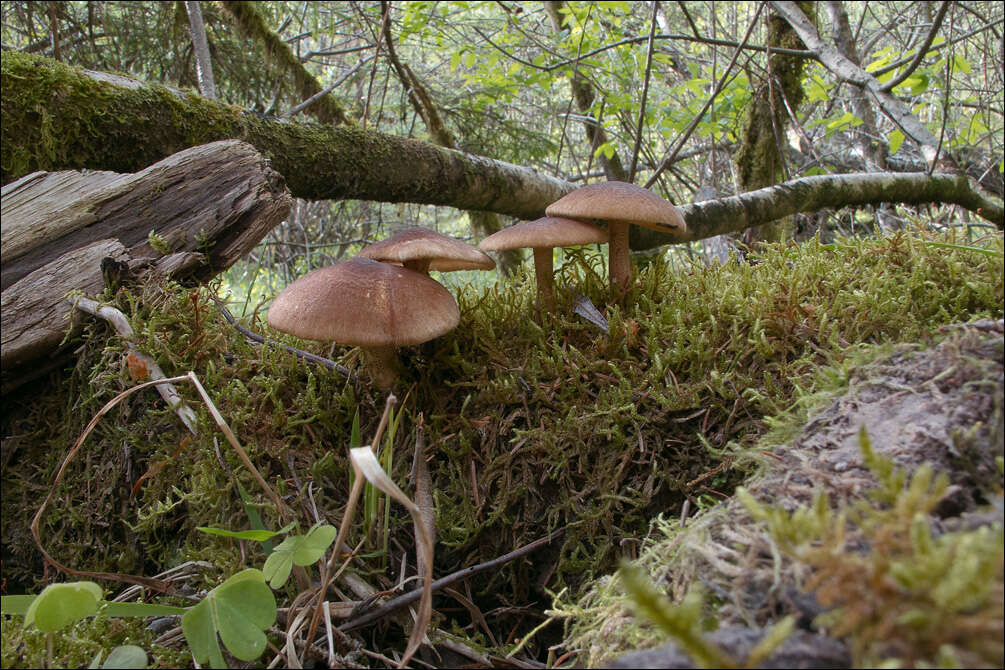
545,182 -> 687,235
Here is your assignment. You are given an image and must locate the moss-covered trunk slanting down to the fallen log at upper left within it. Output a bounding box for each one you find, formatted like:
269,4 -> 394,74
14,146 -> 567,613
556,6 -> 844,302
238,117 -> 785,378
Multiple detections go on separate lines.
220,0 -> 352,126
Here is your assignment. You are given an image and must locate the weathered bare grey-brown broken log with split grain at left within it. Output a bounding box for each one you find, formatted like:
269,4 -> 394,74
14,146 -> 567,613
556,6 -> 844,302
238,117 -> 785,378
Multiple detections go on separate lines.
0,140 -> 291,391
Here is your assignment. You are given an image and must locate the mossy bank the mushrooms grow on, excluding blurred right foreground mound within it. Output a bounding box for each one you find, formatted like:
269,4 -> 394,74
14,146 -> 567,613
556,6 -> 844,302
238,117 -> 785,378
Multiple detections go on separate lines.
3,227 -> 1003,666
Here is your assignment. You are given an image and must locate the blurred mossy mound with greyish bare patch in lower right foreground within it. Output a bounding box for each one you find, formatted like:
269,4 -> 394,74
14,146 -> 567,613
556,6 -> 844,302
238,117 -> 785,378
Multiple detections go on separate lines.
553,321 -> 1005,667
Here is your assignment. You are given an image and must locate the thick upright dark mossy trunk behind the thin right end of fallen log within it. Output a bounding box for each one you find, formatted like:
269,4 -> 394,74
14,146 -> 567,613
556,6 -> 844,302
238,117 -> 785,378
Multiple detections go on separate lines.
734,2 -> 814,245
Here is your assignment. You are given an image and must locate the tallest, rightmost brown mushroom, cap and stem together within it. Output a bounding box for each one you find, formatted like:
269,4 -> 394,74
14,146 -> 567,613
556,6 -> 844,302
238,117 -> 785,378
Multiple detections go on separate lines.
545,182 -> 687,290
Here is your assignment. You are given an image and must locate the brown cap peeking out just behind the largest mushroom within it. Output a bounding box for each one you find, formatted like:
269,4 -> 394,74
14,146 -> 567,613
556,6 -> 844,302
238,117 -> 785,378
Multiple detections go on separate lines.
359,227 -> 495,272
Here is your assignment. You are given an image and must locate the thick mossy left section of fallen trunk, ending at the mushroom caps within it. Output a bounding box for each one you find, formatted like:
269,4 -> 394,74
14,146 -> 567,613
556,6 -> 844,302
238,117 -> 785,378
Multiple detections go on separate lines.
0,51 -> 576,219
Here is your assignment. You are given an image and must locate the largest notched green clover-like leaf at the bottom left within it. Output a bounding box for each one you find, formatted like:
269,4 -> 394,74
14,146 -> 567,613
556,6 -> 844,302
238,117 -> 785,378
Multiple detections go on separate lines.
182,568 -> 275,668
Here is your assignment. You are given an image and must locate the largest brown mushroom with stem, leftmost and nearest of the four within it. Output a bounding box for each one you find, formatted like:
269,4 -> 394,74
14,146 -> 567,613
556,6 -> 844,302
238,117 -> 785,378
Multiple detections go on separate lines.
268,257 -> 460,390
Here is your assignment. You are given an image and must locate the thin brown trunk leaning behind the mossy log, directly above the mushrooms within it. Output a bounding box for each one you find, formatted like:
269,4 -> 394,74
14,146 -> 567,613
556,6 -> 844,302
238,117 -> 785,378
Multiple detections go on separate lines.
381,2 -> 523,276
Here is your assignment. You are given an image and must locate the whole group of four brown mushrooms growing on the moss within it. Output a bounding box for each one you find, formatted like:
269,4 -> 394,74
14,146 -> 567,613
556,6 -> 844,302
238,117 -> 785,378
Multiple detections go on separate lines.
267,182 -> 686,390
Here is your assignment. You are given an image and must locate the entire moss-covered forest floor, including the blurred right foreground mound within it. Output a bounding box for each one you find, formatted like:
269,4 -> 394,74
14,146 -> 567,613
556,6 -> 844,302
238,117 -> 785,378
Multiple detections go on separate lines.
2,225 -> 1005,667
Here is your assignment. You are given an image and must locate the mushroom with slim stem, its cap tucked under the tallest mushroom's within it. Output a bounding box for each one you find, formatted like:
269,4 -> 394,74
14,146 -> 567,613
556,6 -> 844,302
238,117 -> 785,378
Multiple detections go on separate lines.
478,216 -> 607,312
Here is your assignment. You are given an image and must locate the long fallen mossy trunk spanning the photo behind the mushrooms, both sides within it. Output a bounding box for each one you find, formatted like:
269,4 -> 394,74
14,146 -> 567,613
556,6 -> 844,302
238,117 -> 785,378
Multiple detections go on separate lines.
0,51 -> 1003,261
